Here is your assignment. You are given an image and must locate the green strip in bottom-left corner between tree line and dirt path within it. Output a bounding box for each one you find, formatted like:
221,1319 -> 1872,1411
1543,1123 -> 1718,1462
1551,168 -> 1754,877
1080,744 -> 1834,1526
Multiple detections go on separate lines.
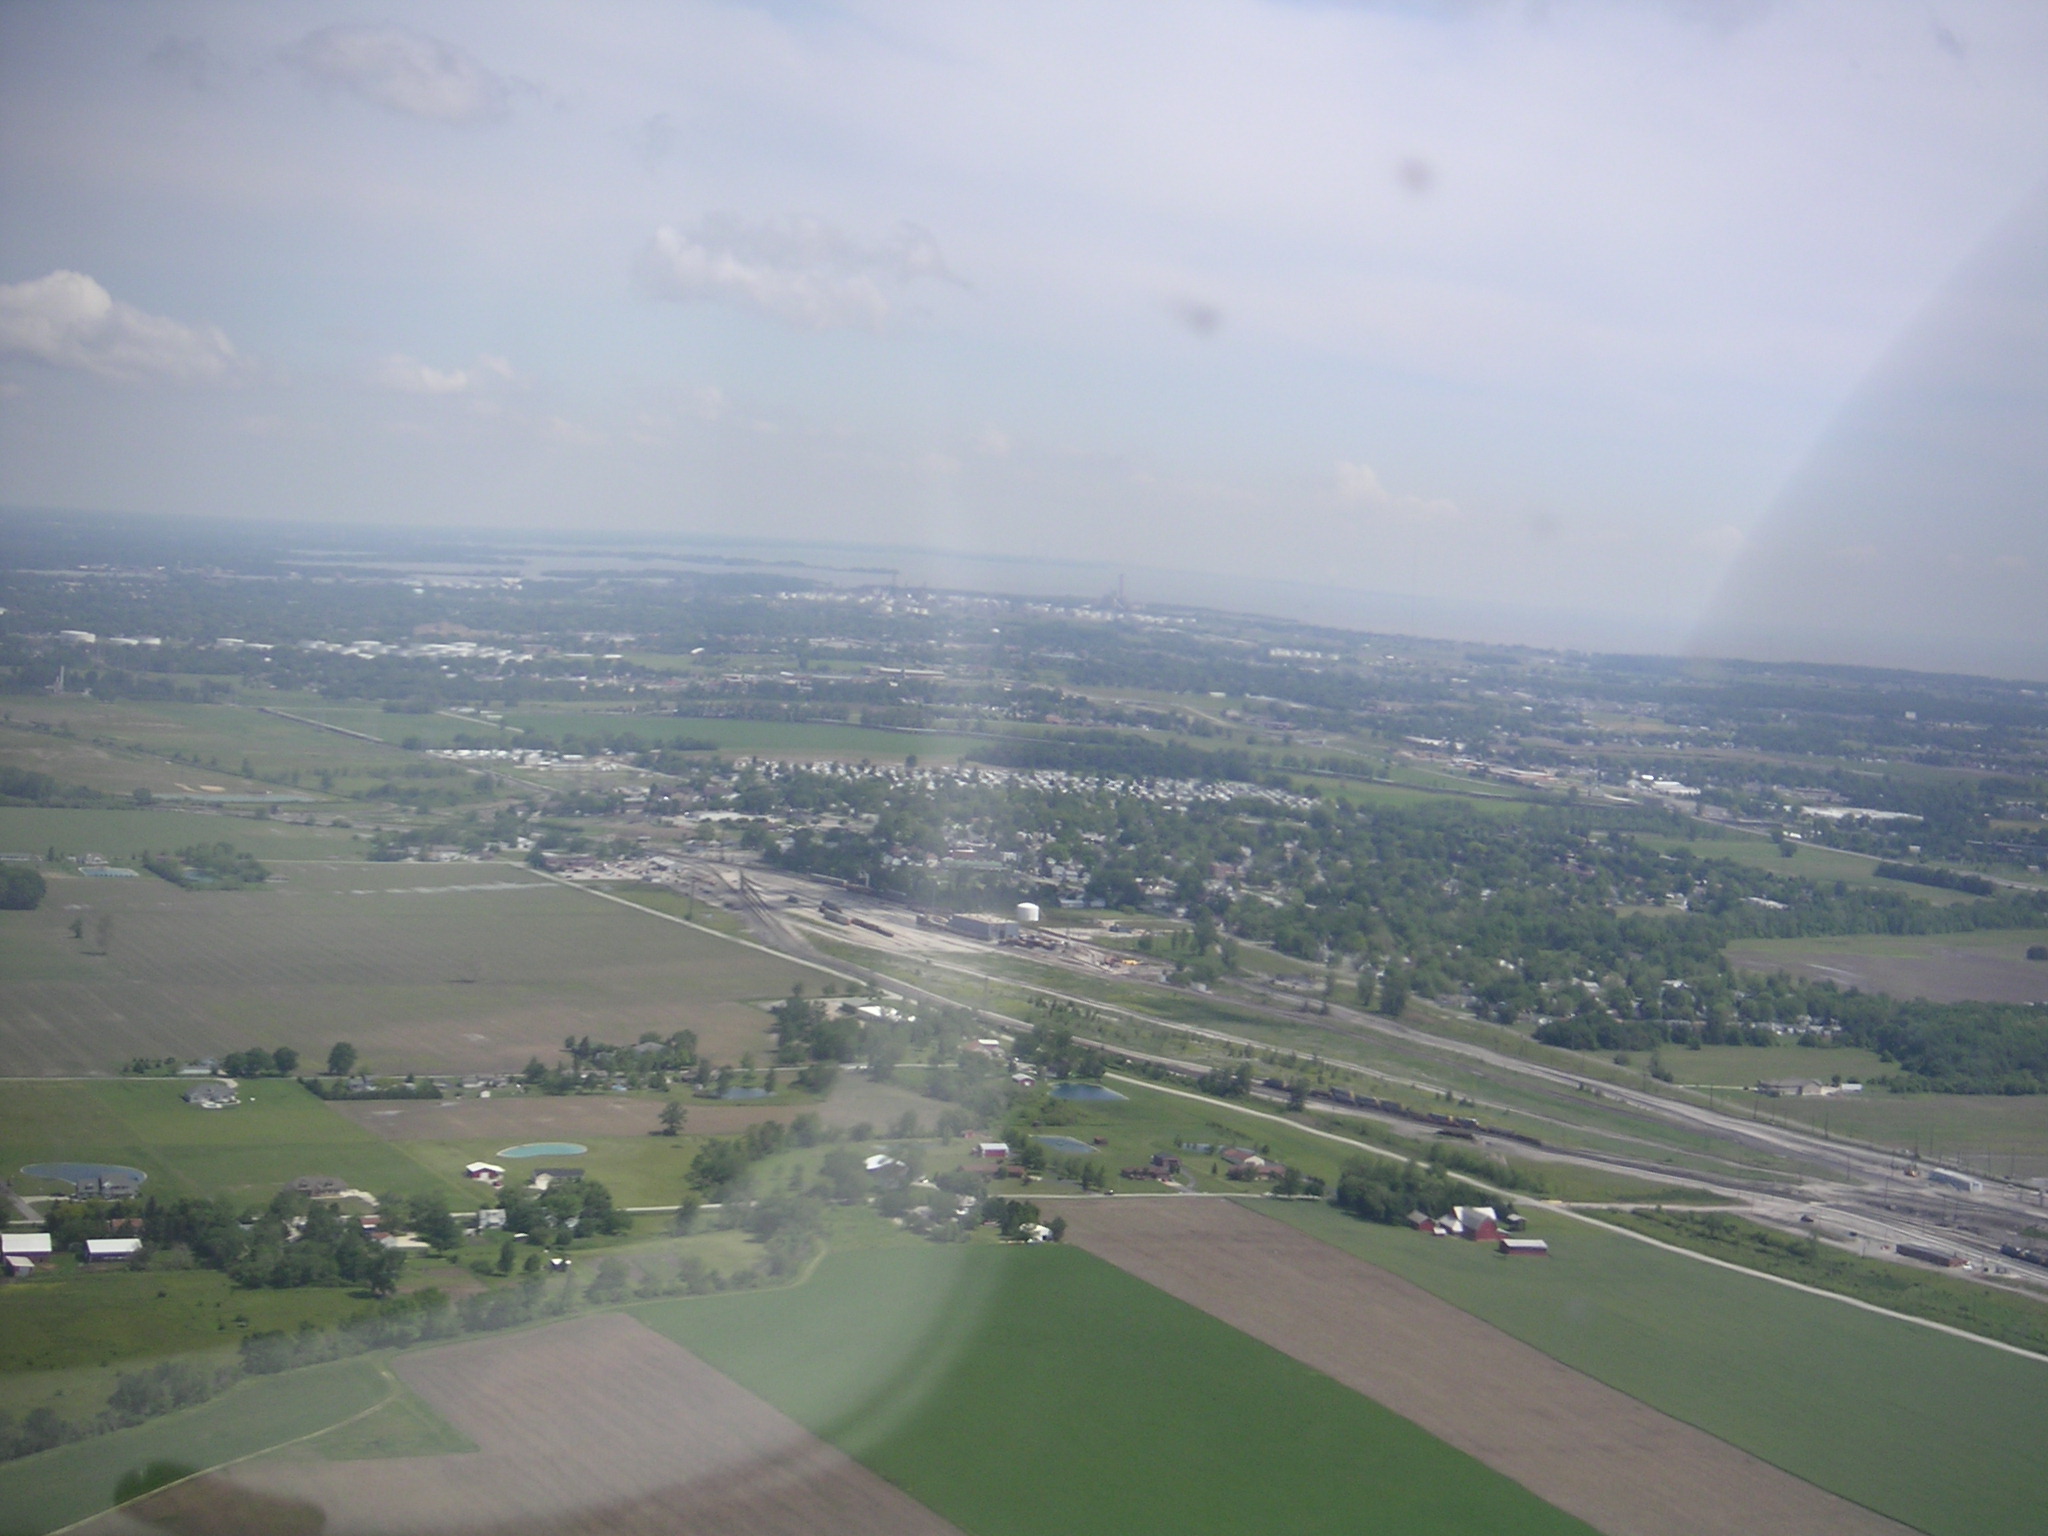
0,1356 -> 393,1536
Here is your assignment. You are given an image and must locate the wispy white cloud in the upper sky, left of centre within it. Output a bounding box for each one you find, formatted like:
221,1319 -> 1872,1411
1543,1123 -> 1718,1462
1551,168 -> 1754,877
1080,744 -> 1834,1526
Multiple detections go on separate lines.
639,213 -> 948,330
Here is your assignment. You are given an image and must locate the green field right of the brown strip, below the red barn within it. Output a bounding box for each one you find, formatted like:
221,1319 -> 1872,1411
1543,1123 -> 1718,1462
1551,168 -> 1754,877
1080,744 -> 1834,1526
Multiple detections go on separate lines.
1257,1202 -> 2048,1536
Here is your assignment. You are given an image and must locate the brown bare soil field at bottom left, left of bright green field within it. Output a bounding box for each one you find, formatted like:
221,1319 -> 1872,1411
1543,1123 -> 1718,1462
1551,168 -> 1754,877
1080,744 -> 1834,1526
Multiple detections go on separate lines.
86,1313 -> 956,1536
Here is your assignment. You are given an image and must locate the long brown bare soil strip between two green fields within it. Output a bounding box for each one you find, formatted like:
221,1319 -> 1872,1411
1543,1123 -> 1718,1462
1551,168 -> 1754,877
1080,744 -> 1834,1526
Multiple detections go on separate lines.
1061,1198 -> 1907,1536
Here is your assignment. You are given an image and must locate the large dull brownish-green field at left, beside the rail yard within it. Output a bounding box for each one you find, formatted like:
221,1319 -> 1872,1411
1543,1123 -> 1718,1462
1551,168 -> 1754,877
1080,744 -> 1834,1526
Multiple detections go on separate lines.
0,860 -> 839,1075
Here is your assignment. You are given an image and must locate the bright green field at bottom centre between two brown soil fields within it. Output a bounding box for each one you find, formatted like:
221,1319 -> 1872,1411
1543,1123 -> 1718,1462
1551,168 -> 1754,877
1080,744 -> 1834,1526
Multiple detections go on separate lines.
637,1243 -> 1585,1536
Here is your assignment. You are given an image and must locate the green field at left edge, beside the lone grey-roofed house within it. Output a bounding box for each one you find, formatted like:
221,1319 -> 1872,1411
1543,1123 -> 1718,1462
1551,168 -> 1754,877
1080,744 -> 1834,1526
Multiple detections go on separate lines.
0,1077 -> 467,1200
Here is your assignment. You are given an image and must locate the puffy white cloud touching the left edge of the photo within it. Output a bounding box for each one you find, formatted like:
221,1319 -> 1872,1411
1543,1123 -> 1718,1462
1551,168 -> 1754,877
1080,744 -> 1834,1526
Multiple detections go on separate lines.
0,270 -> 248,383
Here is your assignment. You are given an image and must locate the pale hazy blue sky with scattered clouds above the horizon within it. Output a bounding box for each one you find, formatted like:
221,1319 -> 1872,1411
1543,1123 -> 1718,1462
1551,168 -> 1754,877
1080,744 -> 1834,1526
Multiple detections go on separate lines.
0,0 -> 2048,676
